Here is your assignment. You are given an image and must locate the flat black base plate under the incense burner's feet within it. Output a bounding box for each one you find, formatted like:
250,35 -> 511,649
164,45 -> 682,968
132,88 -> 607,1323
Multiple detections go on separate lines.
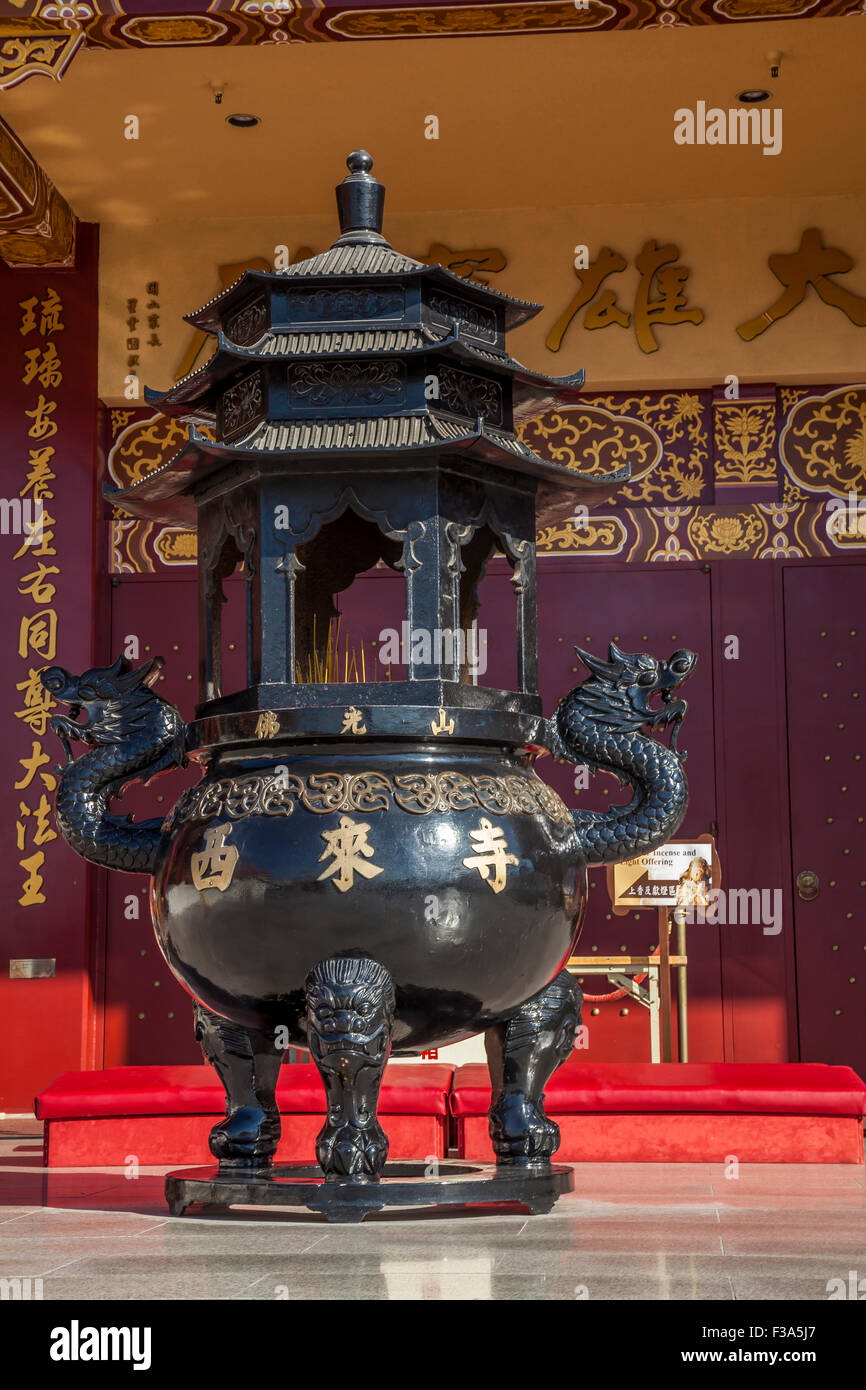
165,1161 -> 574,1222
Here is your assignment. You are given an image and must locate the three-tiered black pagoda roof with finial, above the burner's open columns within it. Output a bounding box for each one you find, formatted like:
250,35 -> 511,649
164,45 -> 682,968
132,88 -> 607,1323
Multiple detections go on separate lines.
106,150 -> 630,525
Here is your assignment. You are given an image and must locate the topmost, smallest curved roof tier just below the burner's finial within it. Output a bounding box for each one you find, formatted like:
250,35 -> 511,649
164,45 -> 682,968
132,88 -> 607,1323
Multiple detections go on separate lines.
183,243 -> 542,334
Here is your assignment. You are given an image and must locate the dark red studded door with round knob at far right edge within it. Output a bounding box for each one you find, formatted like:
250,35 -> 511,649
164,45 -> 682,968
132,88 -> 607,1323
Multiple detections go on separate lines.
784,564 -> 866,1076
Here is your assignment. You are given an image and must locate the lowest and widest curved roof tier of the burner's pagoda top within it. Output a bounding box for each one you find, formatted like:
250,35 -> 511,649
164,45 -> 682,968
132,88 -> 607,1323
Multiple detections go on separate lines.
104,411 -> 631,528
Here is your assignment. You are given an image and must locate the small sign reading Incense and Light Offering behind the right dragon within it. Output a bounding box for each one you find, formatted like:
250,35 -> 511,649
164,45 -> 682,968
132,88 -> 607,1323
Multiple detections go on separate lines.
607,835 -> 721,916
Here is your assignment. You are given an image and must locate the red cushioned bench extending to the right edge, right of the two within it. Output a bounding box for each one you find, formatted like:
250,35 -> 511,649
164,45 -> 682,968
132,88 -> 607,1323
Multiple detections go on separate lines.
450,1061 -> 866,1163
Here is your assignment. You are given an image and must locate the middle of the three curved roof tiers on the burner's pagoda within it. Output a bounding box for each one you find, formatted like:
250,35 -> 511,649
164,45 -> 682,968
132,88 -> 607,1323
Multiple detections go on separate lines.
145,322 -> 584,424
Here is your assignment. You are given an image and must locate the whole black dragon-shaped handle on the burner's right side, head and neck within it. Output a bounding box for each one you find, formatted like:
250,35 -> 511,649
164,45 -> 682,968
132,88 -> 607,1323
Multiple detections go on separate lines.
546,642 -> 698,865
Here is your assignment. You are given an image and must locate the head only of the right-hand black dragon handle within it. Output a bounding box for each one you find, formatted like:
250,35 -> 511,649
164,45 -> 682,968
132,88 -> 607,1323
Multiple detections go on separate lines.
574,642 -> 698,756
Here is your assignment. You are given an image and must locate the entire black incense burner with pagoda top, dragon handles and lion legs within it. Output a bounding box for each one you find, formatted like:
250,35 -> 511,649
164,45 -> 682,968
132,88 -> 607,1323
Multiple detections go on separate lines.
43,152 -> 695,1219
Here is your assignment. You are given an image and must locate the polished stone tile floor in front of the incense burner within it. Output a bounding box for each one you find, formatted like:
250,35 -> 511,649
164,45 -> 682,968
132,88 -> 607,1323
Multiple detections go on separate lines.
0,1156 -> 866,1302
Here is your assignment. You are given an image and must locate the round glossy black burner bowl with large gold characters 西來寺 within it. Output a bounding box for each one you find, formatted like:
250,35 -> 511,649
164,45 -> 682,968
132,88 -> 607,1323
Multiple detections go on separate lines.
153,739 -> 587,1054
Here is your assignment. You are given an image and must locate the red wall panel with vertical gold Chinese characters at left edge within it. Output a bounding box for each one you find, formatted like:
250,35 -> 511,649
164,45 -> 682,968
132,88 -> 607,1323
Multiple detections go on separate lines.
0,227 -> 99,1112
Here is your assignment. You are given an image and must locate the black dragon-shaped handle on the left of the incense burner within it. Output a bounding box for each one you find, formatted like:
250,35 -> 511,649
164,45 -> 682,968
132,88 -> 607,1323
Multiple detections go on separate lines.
42,656 -> 185,873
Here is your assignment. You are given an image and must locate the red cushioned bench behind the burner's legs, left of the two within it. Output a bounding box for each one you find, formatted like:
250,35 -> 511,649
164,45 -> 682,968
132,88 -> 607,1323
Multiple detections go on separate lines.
35,1062 -> 453,1168
